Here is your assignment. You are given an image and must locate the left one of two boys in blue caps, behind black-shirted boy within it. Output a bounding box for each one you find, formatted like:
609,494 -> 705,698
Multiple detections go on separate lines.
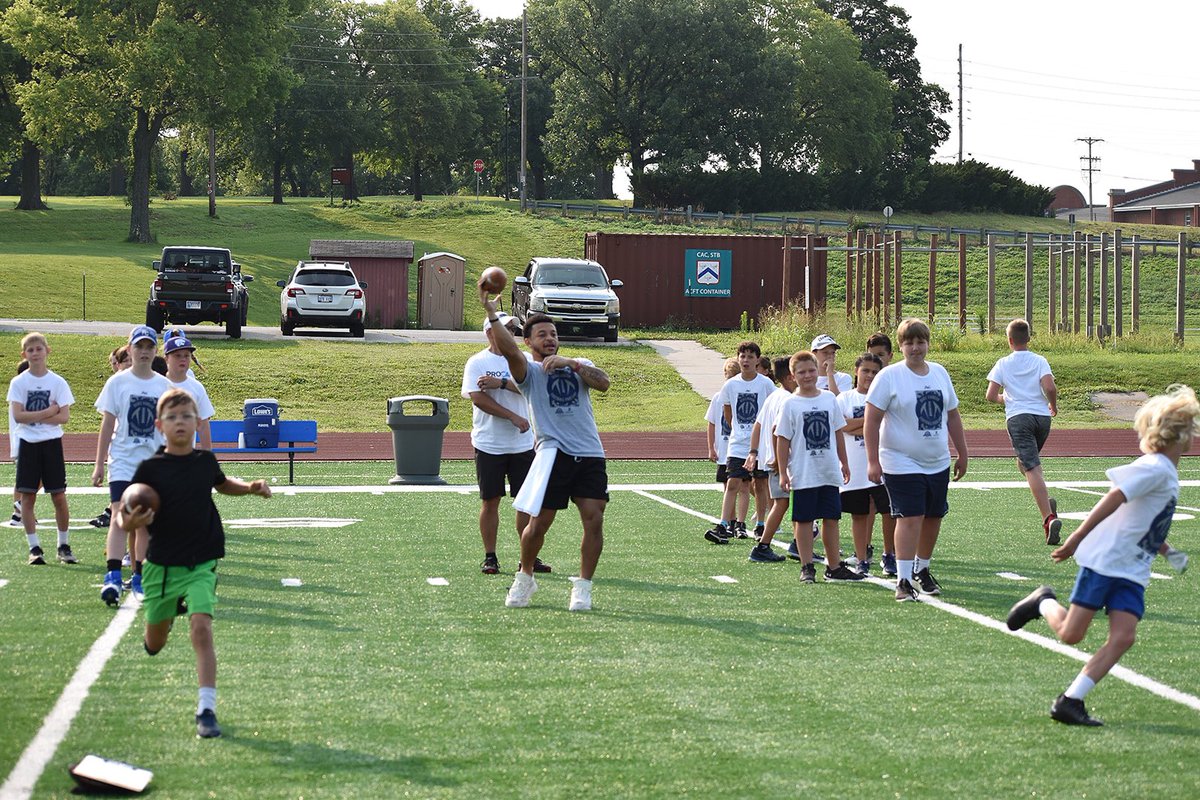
91,325 -> 170,607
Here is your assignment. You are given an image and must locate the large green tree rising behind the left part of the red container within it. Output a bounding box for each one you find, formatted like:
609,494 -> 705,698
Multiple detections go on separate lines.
528,0 -> 745,203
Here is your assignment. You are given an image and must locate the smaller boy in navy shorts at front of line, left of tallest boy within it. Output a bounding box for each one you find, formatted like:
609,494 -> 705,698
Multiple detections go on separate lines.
775,350 -> 864,583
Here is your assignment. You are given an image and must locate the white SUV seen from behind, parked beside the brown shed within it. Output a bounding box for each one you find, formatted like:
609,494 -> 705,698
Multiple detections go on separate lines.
275,261 -> 367,337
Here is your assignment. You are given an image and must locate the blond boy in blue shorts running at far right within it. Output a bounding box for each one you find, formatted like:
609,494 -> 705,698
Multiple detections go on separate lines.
1007,385 -> 1200,726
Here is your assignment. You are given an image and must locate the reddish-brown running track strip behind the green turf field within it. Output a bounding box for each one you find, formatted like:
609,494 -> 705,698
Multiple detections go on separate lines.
46,428 -> 1141,462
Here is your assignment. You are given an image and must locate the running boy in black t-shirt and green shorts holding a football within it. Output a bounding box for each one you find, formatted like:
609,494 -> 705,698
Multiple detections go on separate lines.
115,389 -> 271,739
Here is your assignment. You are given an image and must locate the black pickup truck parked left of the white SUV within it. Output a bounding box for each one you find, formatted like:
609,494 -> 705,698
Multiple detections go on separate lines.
146,246 -> 254,339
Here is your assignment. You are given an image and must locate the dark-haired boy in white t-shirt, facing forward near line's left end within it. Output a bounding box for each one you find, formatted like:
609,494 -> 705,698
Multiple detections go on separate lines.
704,342 -> 775,545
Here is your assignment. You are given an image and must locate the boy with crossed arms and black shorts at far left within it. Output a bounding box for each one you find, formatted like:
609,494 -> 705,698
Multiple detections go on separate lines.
8,333 -> 77,565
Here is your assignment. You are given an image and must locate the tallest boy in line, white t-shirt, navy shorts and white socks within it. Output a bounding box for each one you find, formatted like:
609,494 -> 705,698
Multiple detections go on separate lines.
863,318 -> 967,602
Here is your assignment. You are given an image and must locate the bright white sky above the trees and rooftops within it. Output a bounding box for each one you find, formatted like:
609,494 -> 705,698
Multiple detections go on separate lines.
473,0 -> 1200,205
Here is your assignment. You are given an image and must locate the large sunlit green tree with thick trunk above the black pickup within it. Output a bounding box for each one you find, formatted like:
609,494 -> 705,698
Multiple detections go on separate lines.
4,0 -> 300,242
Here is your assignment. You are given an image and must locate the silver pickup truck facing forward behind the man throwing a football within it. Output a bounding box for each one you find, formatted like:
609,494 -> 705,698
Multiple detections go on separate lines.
512,258 -> 622,342
